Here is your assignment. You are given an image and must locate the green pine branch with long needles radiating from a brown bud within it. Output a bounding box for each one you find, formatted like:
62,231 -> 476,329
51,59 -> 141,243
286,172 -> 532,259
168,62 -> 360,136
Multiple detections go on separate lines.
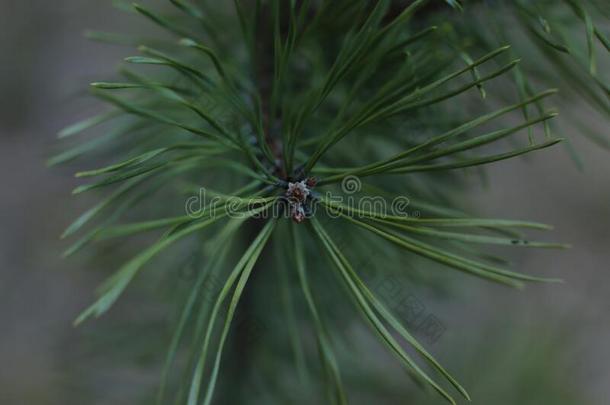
51,0 -> 610,405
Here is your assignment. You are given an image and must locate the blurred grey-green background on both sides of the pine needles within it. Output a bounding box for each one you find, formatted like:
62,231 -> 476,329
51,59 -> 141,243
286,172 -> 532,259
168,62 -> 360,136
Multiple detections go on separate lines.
0,0 -> 610,405
